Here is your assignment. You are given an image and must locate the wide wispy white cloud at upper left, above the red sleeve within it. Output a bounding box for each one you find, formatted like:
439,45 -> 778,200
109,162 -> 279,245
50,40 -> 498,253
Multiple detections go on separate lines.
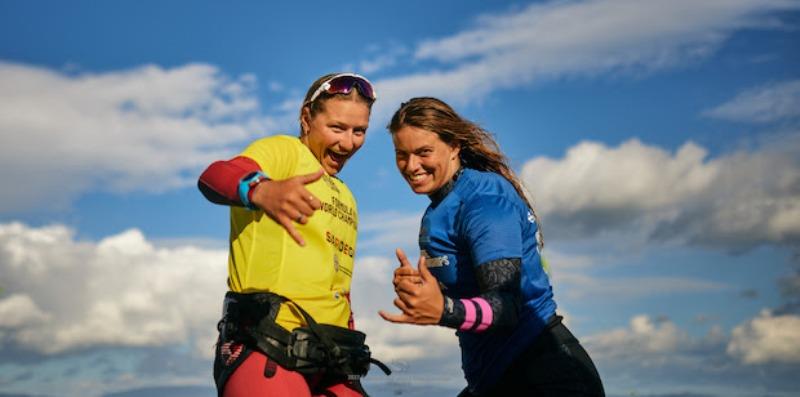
0,62 -> 272,212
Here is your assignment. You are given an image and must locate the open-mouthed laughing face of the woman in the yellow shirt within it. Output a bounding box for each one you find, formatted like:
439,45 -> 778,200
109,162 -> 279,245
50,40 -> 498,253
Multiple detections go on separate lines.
300,97 -> 369,175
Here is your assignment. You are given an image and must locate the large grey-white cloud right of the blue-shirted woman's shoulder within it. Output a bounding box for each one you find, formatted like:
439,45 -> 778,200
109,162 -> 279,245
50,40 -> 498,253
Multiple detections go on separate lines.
521,133 -> 800,251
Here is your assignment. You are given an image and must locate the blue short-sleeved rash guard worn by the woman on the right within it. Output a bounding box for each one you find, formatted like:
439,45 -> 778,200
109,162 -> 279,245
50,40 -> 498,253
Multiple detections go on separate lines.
419,168 -> 556,393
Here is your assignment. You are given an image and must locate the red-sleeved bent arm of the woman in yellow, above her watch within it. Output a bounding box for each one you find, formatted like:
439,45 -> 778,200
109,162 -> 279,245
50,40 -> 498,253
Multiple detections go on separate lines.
197,156 -> 261,206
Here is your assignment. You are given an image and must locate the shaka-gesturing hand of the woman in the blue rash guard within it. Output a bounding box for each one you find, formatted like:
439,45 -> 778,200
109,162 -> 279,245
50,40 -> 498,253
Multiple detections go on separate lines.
378,249 -> 444,325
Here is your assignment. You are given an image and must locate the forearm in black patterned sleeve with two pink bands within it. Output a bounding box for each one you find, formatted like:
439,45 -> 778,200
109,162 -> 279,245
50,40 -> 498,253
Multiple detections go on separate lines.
439,258 -> 520,332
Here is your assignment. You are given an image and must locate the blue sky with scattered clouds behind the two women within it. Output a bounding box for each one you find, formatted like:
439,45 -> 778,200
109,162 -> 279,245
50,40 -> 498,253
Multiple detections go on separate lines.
0,0 -> 800,396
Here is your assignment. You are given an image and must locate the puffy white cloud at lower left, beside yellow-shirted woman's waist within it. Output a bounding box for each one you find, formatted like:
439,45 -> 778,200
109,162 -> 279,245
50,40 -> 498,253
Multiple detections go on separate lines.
0,223 -> 227,358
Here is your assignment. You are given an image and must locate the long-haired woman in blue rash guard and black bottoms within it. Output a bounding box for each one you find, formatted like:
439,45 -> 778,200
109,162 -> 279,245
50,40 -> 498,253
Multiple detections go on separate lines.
380,98 -> 604,397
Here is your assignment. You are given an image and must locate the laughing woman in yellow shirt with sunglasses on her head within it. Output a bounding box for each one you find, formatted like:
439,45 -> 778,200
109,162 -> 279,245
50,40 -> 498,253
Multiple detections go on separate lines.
198,73 -> 376,397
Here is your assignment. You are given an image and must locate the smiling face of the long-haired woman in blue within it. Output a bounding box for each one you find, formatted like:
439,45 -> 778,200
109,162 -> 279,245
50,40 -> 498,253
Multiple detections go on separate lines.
392,125 -> 461,194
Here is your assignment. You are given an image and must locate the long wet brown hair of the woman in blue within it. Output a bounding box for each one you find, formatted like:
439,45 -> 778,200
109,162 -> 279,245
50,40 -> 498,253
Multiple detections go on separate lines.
387,97 -> 544,244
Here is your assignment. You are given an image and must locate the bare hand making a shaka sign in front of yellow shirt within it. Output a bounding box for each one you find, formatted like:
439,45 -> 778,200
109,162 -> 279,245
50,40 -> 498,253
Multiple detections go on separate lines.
250,169 -> 325,246
